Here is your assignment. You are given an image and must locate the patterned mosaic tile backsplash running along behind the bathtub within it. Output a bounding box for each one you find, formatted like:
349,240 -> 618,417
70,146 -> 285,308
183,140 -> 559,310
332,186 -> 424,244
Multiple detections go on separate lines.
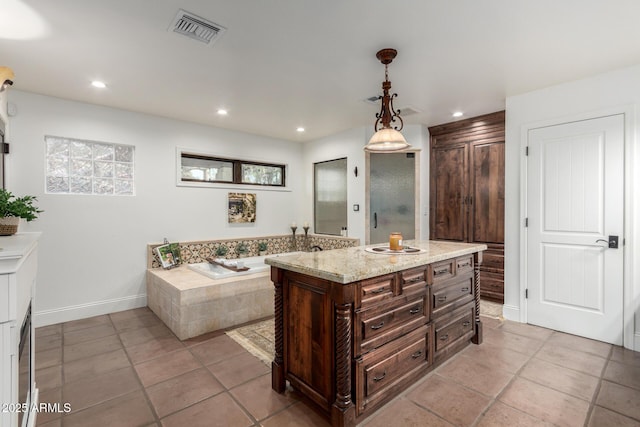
147,234 -> 360,268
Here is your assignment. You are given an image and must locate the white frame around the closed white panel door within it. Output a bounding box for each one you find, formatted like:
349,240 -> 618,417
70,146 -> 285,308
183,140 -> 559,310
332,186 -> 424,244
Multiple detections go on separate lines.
520,105 -> 640,351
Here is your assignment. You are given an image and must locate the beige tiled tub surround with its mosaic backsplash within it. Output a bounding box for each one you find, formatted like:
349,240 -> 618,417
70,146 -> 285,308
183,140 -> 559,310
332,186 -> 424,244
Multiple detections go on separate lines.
147,235 -> 359,340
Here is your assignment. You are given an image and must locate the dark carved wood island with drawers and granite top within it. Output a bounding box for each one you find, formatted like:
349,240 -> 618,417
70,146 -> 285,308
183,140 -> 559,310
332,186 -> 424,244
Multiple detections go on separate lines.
265,241 -> 487,426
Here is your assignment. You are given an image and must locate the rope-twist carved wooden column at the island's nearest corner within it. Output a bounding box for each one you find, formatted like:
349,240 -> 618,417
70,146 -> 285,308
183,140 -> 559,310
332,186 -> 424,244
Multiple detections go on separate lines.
331,303 -> 355,427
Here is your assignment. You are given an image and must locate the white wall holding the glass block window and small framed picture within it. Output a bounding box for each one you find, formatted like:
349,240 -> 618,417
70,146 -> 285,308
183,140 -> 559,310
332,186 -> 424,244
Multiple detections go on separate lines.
6,89 -> 304,326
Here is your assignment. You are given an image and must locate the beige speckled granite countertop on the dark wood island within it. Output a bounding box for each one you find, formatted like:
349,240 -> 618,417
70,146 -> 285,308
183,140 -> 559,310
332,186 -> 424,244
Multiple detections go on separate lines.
264,240 -> 487,284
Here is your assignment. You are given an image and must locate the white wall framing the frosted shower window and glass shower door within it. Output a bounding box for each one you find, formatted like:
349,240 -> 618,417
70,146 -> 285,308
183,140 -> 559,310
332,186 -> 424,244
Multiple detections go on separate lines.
297,125 -> 429,244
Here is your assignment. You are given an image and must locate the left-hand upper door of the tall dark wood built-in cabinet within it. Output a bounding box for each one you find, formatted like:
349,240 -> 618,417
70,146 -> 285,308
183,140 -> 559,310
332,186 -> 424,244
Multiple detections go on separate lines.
431,144 -> 468,241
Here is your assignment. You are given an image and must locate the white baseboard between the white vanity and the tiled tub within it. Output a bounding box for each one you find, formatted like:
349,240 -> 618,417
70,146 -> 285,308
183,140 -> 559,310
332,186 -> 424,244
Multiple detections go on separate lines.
33,294 -> 147,328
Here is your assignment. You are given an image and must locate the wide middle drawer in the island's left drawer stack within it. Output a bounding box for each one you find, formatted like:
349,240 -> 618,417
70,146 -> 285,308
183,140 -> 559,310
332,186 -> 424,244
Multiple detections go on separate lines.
354,288 -> 429,355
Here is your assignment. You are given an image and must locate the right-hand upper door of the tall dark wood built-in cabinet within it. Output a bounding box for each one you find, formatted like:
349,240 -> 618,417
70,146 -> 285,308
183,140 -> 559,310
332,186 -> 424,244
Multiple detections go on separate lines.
469,142 -> 504,243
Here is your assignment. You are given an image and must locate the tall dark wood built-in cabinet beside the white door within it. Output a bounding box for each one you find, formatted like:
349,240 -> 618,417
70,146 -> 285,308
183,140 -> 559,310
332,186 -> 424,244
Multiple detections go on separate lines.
429,111 -> 505,303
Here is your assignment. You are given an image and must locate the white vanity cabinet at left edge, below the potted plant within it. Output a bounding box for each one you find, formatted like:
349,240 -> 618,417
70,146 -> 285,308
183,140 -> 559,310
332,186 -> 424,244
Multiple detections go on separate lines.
0,233 -> 40,427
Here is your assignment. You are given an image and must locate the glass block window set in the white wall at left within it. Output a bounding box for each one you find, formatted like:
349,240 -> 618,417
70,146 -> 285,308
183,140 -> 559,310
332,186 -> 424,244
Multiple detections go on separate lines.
45,136 -> 135,196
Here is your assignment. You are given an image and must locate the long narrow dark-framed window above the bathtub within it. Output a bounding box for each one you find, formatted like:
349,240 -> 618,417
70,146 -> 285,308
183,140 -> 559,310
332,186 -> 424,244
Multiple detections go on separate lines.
180,153 -> 285,187
